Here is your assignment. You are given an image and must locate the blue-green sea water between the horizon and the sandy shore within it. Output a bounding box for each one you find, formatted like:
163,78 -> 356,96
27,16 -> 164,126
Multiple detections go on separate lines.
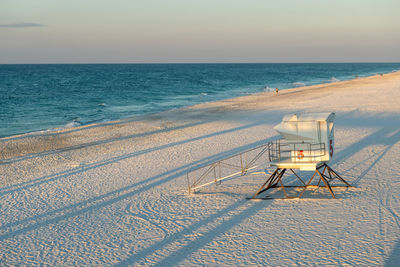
0,63 -> 400,137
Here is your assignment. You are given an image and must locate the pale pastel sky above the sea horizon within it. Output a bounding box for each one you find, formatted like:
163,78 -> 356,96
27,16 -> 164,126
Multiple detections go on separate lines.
0,0 -> 400,63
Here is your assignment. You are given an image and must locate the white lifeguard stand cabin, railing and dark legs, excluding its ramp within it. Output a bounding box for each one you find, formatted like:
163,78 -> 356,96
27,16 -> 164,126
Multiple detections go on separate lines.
253,112 -> 350,198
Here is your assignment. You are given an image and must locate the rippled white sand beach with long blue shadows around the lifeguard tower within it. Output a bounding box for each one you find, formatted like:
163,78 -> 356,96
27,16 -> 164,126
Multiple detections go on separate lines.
0,72 -> 400,266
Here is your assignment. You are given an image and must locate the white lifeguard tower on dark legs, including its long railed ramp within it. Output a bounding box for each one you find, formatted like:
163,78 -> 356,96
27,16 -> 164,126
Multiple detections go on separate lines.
186,113 -> 350,199
